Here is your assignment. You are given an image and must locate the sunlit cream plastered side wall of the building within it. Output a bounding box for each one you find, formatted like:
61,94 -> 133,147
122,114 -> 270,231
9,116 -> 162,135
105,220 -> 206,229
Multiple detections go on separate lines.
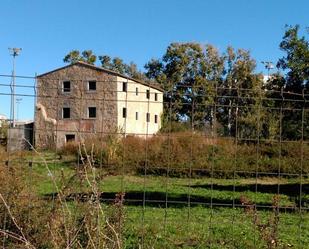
117,76 -> 163,135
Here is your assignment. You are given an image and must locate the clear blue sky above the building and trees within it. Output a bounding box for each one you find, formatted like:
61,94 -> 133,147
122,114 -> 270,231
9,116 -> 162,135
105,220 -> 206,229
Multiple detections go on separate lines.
0,0 -> 309,119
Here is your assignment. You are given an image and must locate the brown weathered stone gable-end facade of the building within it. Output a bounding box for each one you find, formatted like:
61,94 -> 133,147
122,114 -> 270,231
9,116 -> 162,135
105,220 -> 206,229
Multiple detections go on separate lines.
35,63 -> 117,148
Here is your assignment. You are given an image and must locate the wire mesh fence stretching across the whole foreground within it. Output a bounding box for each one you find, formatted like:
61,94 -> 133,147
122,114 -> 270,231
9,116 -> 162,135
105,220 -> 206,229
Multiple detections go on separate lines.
0,72 -> 309,248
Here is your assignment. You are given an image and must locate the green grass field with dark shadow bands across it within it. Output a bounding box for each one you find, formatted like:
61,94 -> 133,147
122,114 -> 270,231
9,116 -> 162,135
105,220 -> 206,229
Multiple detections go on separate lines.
2,153 -> 309,249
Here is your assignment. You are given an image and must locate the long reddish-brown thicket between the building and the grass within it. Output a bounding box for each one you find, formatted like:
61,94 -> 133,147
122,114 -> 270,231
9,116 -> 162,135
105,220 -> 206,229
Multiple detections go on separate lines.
56,131 -> 309,177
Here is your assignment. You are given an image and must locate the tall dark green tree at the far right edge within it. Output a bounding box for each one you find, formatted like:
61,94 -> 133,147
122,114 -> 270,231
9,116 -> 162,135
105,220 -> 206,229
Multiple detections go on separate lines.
272,25 -> 309,140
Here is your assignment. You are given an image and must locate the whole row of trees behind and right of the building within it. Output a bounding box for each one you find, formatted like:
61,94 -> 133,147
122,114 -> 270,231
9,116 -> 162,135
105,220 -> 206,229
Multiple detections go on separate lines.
63,25 -> 309,138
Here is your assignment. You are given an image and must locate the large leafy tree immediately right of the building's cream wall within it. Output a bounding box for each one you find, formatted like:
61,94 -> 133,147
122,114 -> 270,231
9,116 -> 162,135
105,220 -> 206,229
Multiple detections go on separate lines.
145,43 -> 224,127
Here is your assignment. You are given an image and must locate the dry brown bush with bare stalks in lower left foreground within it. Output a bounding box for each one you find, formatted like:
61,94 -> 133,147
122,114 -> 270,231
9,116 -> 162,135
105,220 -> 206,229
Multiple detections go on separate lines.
0,148 -> 124,249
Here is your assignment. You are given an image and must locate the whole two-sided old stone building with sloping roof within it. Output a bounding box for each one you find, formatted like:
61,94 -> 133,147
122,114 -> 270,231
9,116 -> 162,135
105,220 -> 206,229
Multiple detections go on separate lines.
35,62 -> 163,148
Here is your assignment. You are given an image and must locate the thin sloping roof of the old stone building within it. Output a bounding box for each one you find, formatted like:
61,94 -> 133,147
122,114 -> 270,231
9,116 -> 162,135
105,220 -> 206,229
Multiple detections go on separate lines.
37,61 -> 163,92
